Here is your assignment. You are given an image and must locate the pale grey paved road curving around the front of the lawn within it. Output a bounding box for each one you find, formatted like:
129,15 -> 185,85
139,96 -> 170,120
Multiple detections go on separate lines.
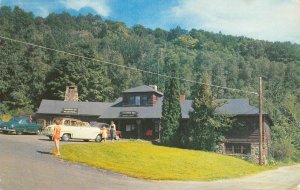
0,134 -> 300,190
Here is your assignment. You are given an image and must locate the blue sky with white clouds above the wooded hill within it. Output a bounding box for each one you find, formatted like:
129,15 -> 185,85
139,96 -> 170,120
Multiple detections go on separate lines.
0,0 -> 300,44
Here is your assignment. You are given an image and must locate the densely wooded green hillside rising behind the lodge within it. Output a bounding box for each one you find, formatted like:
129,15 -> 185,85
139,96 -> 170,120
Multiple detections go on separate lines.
0,7 -> 300,160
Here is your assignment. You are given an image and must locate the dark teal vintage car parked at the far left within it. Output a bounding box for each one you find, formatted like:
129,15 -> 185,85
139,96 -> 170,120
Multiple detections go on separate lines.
1,116 -> 42,135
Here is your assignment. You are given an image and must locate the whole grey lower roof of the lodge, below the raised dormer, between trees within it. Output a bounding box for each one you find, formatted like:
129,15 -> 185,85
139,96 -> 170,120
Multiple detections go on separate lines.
37,97 -> 267,119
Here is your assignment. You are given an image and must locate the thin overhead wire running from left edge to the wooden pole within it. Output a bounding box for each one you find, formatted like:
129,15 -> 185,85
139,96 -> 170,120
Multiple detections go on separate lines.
0,36 -> 258,95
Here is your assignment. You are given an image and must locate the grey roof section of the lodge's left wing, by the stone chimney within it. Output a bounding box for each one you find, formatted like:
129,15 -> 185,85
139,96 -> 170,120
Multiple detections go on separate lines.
37,100 -> 112,116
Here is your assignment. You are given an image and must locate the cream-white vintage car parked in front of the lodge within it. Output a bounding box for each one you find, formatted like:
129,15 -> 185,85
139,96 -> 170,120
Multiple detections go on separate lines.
44,118 -> 101,142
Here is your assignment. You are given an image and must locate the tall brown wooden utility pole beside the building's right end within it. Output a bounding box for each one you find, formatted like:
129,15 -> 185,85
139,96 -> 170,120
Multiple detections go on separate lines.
259,77 -> 263,165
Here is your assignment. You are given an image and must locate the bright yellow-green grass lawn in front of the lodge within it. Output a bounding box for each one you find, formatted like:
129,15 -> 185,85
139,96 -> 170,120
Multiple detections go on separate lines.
61,141 -> 271,181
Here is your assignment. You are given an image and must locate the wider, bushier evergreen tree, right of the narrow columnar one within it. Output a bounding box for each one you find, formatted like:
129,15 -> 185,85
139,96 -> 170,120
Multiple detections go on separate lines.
187,74 -> 231,151
